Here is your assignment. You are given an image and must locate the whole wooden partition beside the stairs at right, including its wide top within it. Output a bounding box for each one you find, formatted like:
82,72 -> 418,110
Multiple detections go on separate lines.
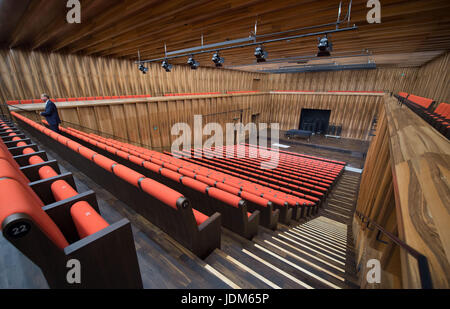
353,96 -> 450,288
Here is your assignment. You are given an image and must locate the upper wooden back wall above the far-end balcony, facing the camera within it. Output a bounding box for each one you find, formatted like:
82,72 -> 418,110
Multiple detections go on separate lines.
267,68 -> 418,92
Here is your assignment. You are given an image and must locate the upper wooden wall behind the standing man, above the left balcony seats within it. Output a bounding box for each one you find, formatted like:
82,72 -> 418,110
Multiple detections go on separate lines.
0,49 -> 266,102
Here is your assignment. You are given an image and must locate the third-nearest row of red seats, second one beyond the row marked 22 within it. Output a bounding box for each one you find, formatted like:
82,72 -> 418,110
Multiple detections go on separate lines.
56,127 -> 260,238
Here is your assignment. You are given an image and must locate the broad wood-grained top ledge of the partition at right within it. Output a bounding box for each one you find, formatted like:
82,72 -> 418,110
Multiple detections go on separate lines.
385,98 -> 450,289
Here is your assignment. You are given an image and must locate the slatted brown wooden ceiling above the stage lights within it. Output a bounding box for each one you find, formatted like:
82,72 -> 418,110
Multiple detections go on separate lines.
0,0 -> 450,70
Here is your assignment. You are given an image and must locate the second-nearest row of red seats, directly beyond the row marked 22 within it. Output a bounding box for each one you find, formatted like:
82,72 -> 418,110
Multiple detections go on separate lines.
13,113 -> 221,258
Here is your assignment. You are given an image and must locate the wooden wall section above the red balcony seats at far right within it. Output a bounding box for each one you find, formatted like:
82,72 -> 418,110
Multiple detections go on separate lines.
412,52 -> 450,103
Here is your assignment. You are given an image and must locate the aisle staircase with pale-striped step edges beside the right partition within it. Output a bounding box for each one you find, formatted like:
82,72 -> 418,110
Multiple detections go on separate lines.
205,171 -> 360,289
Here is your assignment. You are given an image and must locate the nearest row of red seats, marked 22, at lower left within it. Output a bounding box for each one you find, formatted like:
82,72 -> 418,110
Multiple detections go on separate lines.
0,120 -> 142,288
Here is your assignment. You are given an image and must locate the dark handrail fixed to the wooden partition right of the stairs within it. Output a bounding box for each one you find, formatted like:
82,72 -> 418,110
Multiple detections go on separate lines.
355,210 -> 433,289
